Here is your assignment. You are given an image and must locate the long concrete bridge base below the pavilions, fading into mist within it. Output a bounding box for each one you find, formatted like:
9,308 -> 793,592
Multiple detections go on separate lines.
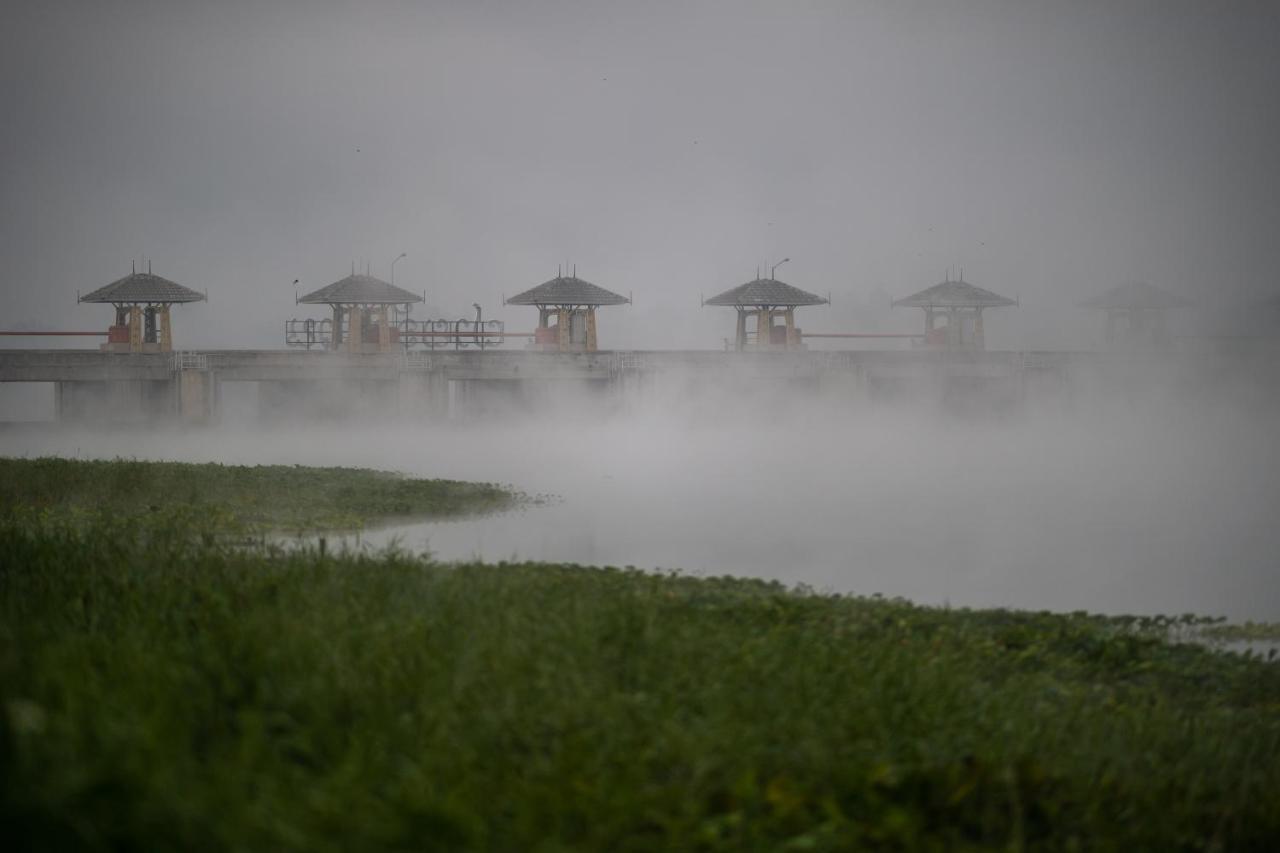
0,350 -> 1259,423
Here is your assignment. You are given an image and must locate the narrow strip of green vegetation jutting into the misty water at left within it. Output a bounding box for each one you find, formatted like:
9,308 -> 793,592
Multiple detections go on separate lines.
0,457 -> 520,530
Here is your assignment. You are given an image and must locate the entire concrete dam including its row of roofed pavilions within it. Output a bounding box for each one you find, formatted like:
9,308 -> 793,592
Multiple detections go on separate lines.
0,265 -> 1280,424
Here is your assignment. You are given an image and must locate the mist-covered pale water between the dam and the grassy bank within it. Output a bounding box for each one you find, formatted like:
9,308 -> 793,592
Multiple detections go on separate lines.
0,371 -> 1280,620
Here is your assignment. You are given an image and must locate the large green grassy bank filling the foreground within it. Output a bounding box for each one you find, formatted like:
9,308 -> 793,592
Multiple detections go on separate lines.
0,458 -> 1280,850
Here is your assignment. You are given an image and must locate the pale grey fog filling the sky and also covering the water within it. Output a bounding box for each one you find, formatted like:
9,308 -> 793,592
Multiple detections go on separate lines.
0,0 -> 1280,619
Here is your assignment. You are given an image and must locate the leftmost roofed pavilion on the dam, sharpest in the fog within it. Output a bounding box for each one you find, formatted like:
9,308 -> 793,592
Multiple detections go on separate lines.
77,264 -> 206,352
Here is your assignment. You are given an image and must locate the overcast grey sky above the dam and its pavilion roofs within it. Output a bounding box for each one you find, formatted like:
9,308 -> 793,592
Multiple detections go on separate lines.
0,0 -> 1280,347
